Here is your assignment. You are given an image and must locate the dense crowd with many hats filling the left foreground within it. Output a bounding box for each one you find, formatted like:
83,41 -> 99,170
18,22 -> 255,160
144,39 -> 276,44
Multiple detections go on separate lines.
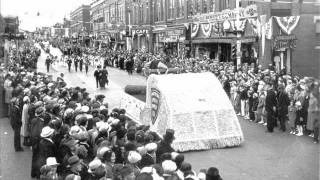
1,41 -> 225,180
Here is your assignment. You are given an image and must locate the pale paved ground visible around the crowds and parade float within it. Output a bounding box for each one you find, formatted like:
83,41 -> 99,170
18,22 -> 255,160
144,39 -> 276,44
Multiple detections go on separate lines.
0,46 -> 320,180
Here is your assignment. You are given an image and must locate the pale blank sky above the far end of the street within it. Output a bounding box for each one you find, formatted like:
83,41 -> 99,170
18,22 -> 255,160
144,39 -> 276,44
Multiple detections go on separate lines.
0,0 -> 92,31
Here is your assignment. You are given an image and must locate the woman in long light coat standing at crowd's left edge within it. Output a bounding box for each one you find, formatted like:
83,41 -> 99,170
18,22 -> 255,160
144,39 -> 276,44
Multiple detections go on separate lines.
21,96 -> 30,146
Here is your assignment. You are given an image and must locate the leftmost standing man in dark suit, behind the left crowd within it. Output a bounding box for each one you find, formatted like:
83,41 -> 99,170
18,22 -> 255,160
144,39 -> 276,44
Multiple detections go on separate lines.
10,98 -> 23,152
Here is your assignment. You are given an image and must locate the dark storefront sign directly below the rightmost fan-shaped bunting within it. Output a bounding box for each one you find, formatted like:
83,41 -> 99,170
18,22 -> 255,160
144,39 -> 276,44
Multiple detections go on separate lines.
273,35 -> 297,51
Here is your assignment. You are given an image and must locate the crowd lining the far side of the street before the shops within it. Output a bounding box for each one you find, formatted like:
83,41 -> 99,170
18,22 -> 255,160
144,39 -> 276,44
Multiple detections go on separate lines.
56,43 -> 319,143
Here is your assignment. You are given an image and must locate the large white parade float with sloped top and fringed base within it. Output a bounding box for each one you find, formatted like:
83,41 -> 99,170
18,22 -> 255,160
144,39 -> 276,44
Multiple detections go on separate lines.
121,73 -> 244,152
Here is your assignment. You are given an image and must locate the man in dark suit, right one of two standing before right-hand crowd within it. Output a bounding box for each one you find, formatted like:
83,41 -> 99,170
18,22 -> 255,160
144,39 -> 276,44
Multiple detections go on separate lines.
278,84 -> 290,132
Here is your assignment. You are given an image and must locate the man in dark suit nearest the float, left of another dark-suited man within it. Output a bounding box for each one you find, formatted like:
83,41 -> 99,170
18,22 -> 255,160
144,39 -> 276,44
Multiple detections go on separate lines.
265,83 -> 277,133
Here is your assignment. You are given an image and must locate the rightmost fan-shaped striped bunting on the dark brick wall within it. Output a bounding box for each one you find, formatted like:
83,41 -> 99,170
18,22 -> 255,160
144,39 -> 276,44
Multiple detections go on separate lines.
275,16 -> 300,35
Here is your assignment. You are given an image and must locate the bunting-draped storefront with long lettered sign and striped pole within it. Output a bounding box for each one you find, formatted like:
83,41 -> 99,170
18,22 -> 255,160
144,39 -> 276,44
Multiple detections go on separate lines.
190,5 -> 259,63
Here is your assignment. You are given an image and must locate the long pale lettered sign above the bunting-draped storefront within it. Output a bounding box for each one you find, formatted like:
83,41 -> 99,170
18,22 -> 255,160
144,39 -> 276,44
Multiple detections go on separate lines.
194,5 -> 258,22
